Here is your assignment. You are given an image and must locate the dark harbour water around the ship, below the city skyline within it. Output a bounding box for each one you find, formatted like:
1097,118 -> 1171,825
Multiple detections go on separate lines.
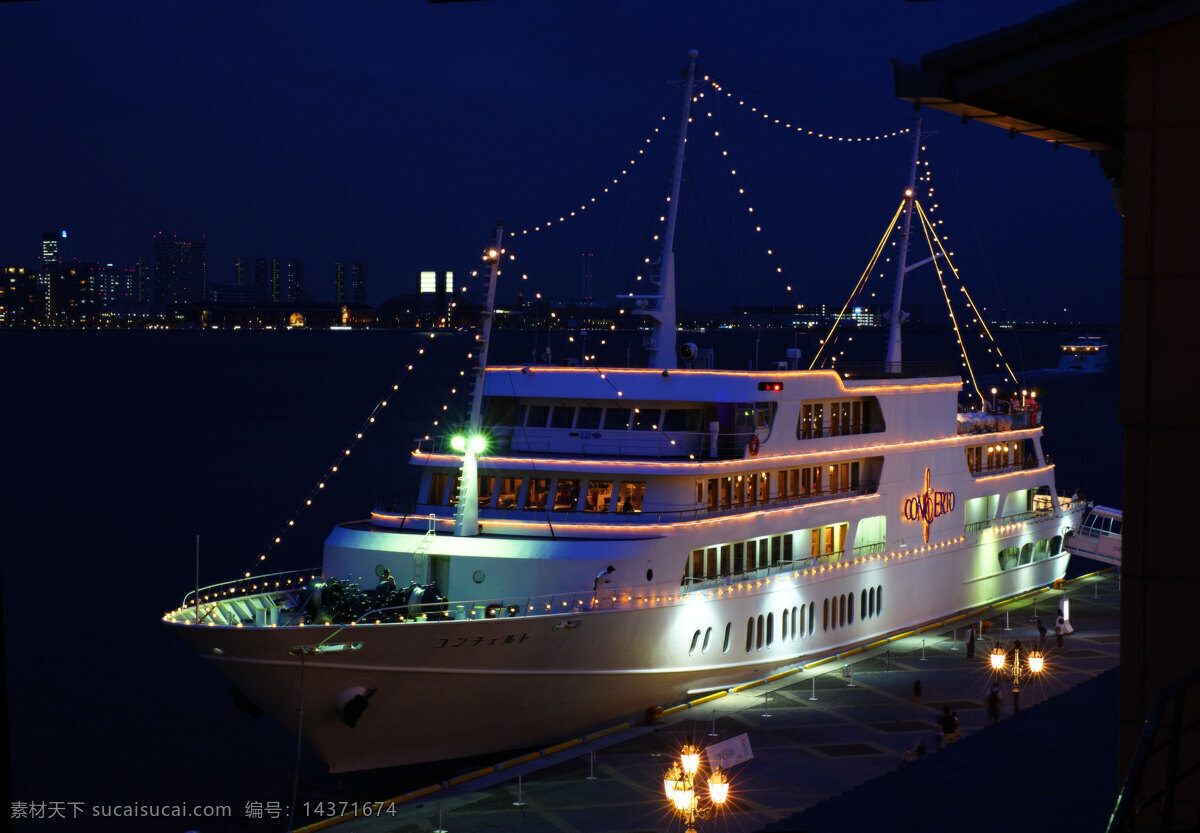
0,331 -> 1121,832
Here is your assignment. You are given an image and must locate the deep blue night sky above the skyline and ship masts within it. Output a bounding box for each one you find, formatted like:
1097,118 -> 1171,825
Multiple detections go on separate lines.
0,0 -> 1120,323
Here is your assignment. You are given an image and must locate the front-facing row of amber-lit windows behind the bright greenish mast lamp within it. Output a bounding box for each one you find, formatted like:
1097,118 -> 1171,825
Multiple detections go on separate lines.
426,472 -> 646,513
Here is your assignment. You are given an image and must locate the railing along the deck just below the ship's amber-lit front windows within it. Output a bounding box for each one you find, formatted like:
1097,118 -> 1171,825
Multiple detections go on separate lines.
374,481 -> 878,529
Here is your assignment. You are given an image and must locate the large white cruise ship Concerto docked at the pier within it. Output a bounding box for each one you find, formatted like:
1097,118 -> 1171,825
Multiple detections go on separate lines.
164,55 -> 1084,772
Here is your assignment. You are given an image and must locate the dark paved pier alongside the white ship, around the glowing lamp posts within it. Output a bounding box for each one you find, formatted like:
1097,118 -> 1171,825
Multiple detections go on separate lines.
295,571 -> 1120,833
